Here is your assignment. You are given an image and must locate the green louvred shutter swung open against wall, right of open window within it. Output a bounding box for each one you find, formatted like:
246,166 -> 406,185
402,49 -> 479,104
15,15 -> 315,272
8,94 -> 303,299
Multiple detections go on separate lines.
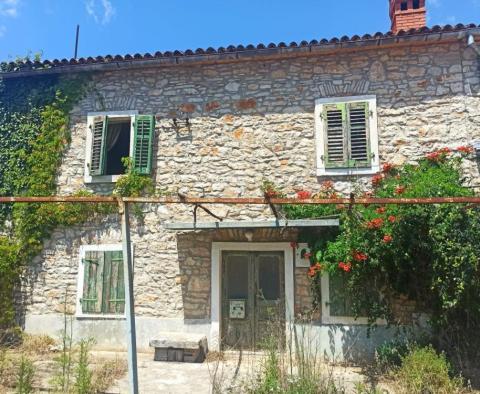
133,115 -> 155,175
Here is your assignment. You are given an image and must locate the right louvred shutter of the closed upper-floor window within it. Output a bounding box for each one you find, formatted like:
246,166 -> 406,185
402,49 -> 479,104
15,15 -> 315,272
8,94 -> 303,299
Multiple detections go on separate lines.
347,102 -> 371,167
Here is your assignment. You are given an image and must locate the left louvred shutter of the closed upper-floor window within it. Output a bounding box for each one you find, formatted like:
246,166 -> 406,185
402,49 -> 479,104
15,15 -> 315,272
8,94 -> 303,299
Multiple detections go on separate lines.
323,103 -> 348,168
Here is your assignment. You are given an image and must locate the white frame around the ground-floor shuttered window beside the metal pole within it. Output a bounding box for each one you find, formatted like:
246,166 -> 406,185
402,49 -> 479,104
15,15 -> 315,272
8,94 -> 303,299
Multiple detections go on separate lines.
75,243 -> 134,320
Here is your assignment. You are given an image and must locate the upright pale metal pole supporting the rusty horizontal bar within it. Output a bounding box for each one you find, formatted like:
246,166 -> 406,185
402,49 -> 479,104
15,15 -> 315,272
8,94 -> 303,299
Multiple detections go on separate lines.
118,199 -> 138,394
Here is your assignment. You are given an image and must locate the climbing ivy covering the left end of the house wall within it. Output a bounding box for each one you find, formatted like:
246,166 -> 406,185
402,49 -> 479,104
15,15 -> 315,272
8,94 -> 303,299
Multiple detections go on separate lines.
0,72 -> 111,328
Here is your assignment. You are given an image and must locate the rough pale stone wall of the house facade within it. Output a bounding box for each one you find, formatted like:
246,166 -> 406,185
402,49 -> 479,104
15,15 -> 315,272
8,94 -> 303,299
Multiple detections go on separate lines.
24,42 -> 480,326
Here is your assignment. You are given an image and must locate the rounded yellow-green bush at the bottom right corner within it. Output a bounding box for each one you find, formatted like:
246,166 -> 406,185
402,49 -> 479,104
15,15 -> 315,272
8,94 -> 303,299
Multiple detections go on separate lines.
393,347 -> 466,394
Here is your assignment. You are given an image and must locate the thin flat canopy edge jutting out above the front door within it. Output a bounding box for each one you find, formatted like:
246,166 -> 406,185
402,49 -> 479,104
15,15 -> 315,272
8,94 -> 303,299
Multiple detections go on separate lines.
163,219 -> 339,230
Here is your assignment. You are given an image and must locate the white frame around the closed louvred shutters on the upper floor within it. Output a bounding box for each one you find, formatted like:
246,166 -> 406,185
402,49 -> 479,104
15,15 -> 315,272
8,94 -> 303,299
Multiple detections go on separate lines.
315,95 -> 380,176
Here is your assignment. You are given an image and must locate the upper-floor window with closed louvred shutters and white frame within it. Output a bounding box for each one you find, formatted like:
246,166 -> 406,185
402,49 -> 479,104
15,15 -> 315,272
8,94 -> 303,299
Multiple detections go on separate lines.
315,96 -> 380,176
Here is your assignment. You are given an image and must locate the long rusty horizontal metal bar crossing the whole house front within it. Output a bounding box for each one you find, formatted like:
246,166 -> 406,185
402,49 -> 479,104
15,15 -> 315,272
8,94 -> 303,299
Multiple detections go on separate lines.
0,196 -> 480,205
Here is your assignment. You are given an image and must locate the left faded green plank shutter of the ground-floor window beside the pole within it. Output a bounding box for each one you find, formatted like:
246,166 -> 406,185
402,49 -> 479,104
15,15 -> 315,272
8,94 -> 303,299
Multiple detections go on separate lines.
81,252 -> 104,313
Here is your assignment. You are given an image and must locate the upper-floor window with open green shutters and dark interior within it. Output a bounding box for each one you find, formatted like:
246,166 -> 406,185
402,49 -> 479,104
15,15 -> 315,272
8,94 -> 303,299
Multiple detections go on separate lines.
85,111 -> 155,182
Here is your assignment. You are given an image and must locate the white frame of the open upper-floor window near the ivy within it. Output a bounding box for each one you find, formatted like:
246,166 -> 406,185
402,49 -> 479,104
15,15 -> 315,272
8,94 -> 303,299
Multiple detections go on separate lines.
84,110 -> 138,183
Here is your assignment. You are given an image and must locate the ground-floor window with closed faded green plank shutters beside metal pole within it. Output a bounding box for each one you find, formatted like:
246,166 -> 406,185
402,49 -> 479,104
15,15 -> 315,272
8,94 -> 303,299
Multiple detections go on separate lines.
78,245 -> 125,315
